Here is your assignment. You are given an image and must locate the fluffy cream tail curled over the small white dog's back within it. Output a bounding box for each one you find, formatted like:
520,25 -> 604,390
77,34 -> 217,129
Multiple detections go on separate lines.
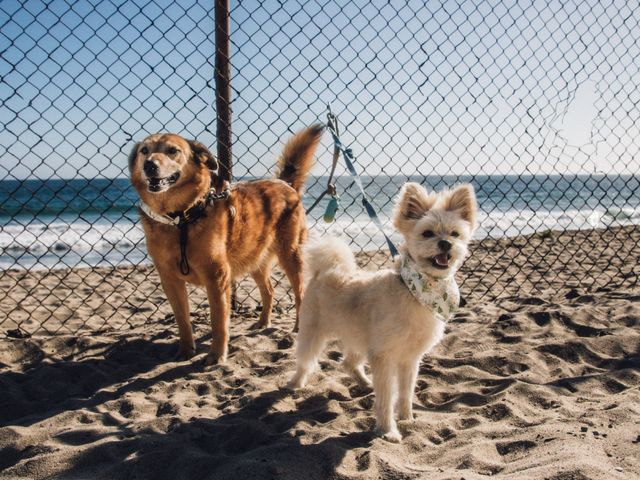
304,237 -> 358,280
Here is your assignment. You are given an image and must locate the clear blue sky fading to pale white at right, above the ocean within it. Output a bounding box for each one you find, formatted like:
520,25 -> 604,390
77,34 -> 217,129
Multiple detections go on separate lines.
0,0 -> 640,180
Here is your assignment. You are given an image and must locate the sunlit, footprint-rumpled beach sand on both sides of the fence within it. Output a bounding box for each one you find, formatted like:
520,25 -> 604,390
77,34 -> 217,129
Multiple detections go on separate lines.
0,227 -> 640,480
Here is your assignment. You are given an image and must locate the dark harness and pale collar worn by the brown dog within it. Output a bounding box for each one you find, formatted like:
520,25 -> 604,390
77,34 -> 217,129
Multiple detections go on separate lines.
138,186 -> 234,275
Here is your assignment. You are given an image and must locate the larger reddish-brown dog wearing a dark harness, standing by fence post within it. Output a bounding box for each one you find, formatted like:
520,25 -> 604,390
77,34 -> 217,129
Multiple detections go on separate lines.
129,125 -> 323,364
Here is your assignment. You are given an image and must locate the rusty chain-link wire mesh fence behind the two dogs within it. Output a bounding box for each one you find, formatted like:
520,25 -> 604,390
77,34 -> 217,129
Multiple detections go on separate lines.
0,0 -> 640,335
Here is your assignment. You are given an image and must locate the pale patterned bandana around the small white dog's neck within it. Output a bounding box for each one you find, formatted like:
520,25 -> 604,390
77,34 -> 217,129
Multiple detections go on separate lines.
400,253 -> 460,322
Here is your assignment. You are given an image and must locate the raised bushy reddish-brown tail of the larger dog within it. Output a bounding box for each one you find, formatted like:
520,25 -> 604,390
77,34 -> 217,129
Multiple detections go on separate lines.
277,123 -> 324,192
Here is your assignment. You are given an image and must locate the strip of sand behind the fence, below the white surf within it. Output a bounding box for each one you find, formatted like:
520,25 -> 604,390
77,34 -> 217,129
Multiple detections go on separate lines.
0,226 -> 640,336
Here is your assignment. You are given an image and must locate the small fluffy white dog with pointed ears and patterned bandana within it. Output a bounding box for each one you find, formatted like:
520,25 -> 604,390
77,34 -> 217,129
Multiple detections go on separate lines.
289,183 -> 477,442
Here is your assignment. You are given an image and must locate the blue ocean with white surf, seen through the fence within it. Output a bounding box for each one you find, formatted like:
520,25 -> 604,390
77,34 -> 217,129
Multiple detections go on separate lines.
0,175 -> 640,270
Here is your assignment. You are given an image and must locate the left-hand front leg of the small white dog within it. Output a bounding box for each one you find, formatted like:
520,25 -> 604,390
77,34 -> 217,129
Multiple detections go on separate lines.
371,355 -> 402,443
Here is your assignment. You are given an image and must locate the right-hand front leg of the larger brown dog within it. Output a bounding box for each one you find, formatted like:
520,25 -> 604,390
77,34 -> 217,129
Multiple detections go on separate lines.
205,267 -> 231,365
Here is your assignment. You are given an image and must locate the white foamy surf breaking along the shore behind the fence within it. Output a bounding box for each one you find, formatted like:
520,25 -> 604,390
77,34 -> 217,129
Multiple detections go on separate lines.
0,207 -> 640,269
